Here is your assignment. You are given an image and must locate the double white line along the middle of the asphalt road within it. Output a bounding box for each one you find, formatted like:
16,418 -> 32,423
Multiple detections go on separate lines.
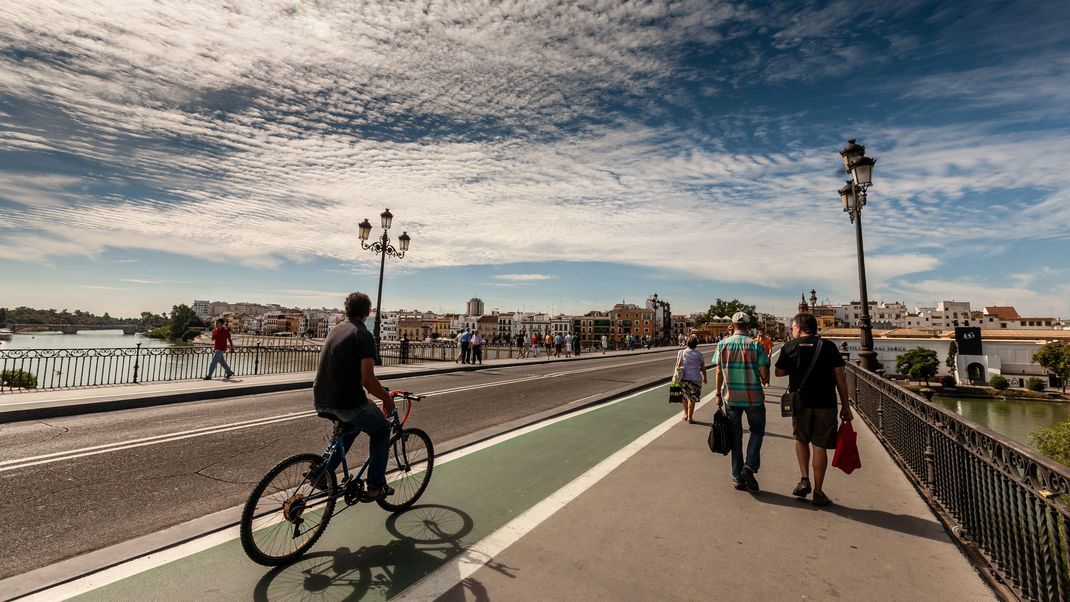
0,358 -> 676,473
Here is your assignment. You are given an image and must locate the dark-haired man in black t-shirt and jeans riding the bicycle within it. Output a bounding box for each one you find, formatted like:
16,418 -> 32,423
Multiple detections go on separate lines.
312,293 -> 394,501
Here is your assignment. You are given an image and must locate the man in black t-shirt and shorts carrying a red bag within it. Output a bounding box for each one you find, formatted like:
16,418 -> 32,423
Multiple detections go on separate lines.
776,313 -> 854,506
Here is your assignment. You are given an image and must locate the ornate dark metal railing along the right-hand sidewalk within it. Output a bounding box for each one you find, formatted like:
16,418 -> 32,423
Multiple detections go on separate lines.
847,364 -> 1070,601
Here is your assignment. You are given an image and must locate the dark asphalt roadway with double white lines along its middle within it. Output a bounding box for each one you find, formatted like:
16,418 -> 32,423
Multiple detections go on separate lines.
0,349 -> 676,578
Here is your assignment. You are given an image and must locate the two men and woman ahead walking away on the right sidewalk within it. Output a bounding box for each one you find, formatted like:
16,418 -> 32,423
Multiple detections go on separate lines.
676,311 -> 854,506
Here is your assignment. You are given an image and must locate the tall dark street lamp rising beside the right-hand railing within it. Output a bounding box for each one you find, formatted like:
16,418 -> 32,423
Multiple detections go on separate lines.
839,140 -> 877,372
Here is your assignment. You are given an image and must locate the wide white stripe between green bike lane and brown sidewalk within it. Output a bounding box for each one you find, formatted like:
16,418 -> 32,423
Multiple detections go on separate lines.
393,393 -> 714,601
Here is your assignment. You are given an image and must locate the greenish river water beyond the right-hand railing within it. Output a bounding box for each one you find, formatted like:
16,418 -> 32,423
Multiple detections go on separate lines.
933,397 -> 1070,448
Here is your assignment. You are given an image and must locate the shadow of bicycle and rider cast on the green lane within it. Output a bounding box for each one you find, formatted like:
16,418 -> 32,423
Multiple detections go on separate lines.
253,504 -> 513,601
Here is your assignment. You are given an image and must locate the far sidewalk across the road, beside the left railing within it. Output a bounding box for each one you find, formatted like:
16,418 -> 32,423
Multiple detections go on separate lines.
0,348 -> 676,423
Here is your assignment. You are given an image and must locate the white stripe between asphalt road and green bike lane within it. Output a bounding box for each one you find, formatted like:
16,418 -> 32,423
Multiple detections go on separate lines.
19,385 -> 659,602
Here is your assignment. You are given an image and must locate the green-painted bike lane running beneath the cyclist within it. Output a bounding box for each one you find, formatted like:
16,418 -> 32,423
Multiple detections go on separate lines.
52,386 -> 679,601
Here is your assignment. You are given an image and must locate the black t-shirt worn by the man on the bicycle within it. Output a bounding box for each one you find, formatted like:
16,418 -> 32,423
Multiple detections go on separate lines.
312,320 -> 376,407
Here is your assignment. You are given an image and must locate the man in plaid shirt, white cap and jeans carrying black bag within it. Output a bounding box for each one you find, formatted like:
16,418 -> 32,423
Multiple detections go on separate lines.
714,311 -> 769,492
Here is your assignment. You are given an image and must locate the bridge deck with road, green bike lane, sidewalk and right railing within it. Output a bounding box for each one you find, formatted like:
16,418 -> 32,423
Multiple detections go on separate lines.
0,350 -> 1070,601
